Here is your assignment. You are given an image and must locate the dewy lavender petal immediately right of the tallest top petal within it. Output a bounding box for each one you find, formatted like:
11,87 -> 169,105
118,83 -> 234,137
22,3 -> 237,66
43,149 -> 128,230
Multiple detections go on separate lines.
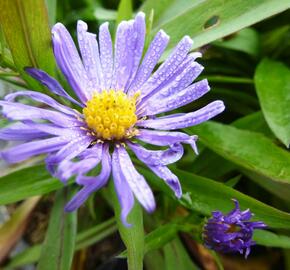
128,30 -> 169,95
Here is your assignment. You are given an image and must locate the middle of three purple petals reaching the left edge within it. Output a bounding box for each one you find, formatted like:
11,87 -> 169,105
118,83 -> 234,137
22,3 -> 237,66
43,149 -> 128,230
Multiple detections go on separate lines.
0,123 -> 47,141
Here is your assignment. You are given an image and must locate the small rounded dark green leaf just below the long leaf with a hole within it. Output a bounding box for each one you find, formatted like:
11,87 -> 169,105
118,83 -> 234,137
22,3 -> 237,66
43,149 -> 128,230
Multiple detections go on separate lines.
214,28 -> 260,57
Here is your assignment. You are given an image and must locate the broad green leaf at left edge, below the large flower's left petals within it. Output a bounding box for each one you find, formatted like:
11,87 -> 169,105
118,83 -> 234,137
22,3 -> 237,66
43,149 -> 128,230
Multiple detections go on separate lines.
0,165 -> 63,205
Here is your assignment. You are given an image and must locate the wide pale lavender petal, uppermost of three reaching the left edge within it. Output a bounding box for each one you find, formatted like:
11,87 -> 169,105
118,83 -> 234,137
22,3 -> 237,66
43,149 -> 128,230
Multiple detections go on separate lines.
0,100 -> 82,127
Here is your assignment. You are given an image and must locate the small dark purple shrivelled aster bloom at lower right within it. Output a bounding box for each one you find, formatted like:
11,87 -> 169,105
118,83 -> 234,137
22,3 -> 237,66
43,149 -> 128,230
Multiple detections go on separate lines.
203,199 -> 267,258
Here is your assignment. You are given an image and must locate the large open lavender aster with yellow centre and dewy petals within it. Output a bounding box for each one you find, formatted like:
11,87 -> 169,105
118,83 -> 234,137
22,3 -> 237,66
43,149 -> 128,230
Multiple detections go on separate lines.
0,13 -> 224,225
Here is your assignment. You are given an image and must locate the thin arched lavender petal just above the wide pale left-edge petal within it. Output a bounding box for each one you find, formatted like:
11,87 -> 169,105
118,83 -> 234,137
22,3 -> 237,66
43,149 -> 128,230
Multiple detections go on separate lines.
5,90 -> 79,117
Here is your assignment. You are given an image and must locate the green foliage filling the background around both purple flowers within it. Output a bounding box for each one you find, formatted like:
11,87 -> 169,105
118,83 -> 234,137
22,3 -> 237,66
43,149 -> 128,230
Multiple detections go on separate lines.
0,0 -> 290,270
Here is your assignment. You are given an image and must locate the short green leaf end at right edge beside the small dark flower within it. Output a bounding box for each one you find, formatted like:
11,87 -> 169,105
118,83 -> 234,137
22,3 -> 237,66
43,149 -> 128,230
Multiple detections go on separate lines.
253,230 -> 290,248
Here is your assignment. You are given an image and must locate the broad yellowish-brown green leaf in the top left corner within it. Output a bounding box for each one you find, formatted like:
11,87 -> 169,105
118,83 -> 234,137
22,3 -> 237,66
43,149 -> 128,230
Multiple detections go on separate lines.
0,0 -> 54,89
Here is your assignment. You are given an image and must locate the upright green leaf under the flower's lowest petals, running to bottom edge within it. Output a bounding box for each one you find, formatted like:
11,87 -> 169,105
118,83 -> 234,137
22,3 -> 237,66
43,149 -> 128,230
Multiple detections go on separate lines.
110,181 -> 144,270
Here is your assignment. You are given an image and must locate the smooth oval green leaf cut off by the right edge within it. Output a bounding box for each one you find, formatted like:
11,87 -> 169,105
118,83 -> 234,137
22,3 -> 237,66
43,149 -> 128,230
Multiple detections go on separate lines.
255,59 -> 290,147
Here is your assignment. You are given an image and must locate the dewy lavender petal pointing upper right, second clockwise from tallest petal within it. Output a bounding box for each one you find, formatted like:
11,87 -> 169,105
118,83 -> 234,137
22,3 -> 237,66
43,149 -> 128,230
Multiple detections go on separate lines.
139,36 -> 192,97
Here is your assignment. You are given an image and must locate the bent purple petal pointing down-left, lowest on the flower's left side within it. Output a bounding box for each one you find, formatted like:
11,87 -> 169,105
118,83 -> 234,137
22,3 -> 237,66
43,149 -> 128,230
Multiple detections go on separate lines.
65,144 -> 111,212
